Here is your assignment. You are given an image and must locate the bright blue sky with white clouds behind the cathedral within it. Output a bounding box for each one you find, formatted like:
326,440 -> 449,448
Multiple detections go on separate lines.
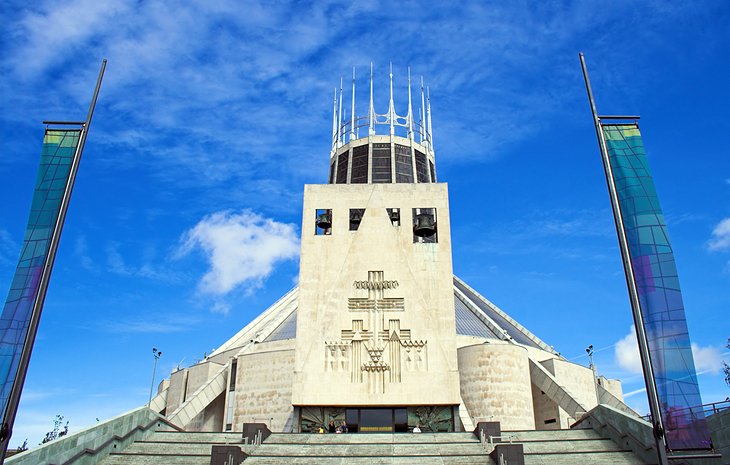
0,0 -> 730,446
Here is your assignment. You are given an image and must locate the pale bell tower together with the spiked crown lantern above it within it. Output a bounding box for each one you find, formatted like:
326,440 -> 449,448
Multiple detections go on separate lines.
292,66 -> 460,431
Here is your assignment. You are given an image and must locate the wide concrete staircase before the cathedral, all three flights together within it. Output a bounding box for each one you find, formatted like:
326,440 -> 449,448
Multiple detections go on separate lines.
101,429 -> 646,465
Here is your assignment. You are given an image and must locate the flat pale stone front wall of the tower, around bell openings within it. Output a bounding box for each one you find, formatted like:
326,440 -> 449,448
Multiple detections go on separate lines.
293,183 -> 459,406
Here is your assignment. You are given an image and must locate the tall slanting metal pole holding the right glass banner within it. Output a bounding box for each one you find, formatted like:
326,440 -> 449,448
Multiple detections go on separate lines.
578,53 -> 669,465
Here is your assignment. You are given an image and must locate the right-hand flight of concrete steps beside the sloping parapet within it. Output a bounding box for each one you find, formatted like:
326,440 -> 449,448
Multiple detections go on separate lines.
502,429 -> 647,465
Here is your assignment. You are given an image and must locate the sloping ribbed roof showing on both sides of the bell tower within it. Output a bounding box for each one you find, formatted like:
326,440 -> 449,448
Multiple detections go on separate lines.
213,276 -> 555,355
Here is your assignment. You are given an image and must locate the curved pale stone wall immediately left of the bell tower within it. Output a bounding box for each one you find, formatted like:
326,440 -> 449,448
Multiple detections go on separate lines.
233,350 -> 294,431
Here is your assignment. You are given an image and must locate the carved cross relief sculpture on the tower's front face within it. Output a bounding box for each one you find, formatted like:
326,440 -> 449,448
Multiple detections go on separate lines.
325,271 -> 428,393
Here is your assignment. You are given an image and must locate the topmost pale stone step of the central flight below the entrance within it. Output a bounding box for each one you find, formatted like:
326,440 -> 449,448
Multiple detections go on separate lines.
264,433 -> 479,444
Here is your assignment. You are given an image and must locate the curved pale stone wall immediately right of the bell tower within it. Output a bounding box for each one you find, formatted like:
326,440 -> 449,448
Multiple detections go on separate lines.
458,344 -> 535,430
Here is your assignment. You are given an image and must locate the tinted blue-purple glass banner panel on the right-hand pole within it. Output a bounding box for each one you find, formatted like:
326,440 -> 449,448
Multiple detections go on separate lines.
602,124 -> 710,450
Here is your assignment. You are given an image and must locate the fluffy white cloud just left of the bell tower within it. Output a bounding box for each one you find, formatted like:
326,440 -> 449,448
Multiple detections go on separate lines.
178,211 -> 299,294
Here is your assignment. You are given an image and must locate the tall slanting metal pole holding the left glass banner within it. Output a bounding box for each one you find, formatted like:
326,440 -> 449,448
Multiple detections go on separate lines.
0,59 -> 106,465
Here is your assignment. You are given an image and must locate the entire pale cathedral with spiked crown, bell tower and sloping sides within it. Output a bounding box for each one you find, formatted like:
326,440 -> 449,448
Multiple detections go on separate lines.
150,69 -> 635,432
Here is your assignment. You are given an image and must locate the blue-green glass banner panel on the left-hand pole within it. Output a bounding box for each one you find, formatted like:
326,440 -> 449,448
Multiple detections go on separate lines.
0,129 -> 81,415
